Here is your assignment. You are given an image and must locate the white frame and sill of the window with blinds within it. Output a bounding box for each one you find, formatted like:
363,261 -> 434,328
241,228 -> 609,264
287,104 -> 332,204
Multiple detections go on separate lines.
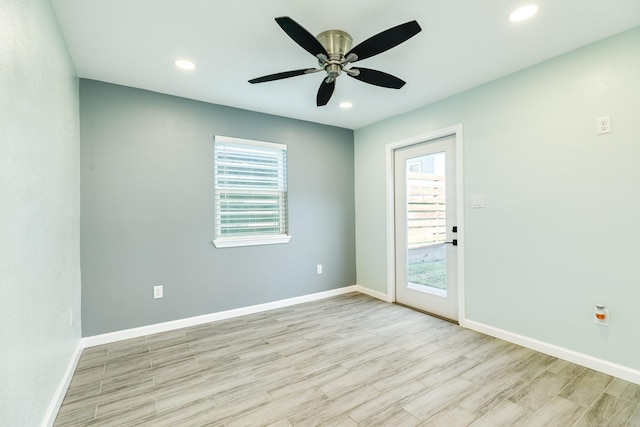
213,135 -> 291,248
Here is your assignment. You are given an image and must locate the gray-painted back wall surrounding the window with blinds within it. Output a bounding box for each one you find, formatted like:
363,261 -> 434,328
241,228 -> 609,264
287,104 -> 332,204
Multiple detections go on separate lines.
80,79 -> 356,336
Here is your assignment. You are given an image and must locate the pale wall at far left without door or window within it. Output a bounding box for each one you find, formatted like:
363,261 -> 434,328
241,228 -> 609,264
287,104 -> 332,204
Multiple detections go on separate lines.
0,0 -> 80,426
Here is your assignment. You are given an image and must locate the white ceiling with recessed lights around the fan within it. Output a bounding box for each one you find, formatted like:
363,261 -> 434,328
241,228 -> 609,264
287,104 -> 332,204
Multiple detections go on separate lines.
52,0 -> 640,129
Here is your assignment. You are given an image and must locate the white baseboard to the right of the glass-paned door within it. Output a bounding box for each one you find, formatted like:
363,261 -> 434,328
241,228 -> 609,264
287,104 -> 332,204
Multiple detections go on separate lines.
460,319 -> 640,385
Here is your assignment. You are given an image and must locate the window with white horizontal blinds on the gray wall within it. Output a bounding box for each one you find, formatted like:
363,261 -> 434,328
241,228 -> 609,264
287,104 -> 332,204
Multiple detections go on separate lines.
213,135 -> 291,248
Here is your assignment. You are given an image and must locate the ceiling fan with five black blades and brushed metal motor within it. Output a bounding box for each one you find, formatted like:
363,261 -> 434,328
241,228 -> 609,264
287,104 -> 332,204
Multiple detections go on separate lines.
249,16 -> 422,107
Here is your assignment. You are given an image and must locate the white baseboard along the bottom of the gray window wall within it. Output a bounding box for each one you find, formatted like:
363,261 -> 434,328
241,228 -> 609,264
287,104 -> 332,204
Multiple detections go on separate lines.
82,285 -> 357,348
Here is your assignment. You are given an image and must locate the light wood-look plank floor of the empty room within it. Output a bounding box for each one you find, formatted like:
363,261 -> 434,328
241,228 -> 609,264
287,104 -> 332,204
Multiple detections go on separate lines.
55,294 -> 640,427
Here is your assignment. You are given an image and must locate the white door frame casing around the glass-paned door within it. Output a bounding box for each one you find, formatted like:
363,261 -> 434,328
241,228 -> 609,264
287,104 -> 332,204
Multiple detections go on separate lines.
386,123 -> 466,323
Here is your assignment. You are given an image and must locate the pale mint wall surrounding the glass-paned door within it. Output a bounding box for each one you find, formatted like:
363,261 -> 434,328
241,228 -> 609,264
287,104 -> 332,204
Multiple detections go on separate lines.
355,28 -> 640,370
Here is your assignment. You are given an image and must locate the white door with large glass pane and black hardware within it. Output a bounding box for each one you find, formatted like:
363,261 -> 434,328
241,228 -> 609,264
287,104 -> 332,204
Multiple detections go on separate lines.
394,136 -> 458,321
